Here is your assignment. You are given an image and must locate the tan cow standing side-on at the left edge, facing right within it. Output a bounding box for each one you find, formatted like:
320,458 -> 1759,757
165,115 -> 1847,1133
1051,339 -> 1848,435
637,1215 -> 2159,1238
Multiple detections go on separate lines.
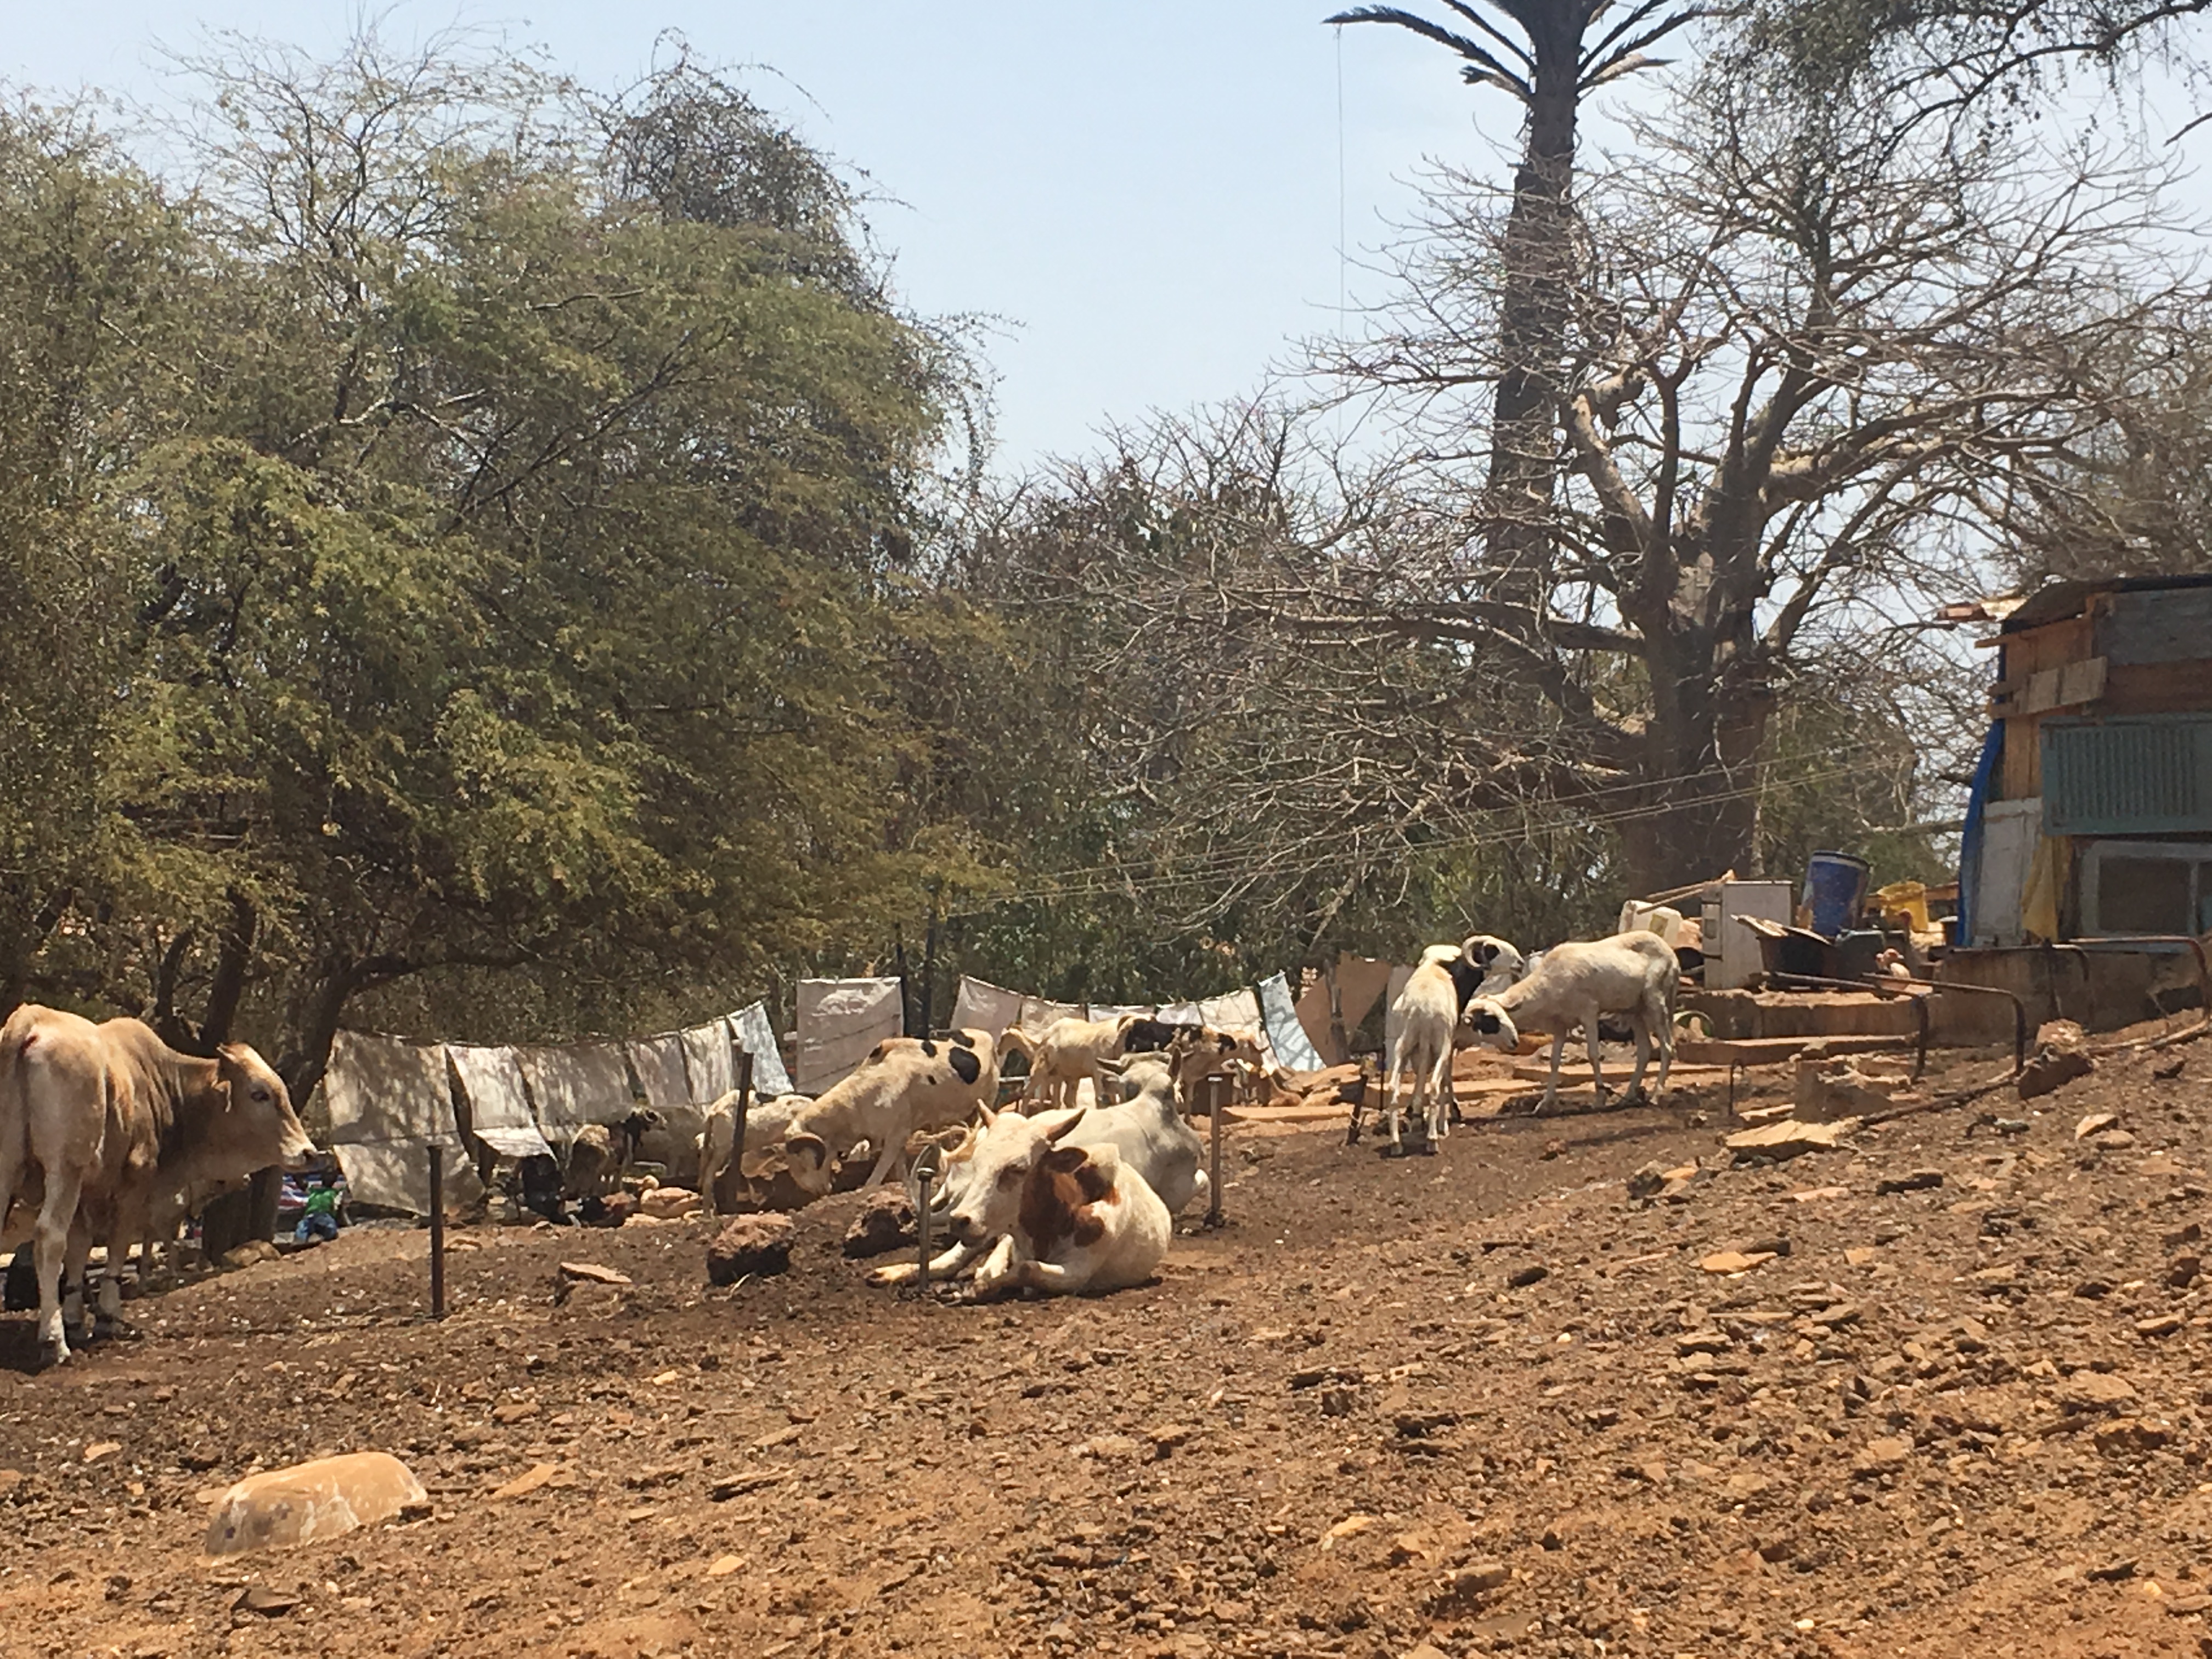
0,1005 -> 314,1363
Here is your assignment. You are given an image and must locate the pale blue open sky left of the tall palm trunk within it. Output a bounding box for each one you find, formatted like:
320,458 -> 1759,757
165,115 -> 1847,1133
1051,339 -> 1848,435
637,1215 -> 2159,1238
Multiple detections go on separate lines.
0,0 -> 1515,469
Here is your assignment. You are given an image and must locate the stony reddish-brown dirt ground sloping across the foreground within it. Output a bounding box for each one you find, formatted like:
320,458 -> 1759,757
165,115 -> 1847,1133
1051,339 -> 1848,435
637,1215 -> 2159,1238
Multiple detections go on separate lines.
0,1042 -> 2212,1659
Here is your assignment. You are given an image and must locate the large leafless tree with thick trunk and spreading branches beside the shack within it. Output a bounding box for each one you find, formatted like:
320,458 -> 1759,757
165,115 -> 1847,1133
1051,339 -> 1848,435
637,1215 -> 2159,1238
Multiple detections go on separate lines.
1031,61 -> 2179,913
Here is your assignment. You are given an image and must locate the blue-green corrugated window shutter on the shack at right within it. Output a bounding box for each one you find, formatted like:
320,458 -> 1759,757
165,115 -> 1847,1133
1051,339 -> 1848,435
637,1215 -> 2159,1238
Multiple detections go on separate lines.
2042,714 -> 2212,836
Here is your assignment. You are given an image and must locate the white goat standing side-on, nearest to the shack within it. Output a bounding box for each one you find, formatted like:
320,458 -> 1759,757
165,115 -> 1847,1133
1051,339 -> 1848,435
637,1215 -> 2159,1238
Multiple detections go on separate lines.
1466,934 -> 1681,1110
